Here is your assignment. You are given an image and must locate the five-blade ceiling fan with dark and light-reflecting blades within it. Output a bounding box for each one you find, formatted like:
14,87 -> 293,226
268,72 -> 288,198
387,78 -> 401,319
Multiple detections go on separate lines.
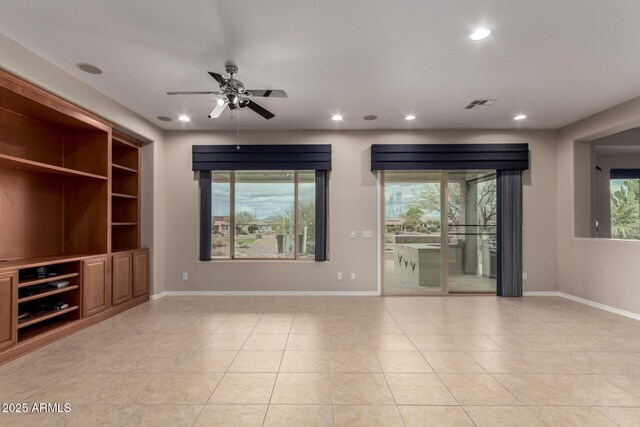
167,64 -> 287,120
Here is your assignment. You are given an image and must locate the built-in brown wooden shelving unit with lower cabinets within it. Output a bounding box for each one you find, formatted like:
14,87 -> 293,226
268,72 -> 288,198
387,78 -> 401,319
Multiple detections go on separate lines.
0,70 -> 149,363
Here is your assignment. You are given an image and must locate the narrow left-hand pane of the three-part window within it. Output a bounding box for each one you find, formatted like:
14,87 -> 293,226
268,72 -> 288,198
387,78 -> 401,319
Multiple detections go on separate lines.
211,171 -> 231,258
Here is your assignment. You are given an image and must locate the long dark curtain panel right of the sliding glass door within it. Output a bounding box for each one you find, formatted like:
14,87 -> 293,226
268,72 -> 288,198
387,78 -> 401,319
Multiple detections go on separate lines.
496,170 -> 522,297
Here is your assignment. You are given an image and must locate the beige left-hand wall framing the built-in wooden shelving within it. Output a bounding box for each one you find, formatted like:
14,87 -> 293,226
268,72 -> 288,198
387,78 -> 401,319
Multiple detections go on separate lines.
0,34 -> 165,293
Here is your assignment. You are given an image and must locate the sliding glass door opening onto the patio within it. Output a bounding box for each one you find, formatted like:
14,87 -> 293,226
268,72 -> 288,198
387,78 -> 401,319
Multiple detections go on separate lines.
383,171 -> 496,295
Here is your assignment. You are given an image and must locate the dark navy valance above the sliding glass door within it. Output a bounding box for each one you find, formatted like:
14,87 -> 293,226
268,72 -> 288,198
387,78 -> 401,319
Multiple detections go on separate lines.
371,144 -> 529,170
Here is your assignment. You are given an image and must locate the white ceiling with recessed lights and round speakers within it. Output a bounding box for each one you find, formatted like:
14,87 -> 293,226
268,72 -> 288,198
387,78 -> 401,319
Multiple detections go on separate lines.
0,0 -> 640,129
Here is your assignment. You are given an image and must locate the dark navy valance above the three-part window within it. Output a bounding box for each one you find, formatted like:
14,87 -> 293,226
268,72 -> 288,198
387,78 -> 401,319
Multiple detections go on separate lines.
192,144 -> 331,171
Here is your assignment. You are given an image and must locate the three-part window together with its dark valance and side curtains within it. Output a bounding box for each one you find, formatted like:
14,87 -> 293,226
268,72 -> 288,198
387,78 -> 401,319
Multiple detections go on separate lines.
192,144 -> 331,262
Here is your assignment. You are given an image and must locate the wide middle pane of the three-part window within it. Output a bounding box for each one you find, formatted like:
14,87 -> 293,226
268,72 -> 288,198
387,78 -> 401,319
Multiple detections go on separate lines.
234,171 -> 295,258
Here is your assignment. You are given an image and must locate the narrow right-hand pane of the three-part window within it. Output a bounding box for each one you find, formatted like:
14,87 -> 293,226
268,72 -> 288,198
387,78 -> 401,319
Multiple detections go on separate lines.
298,171 -> 316,258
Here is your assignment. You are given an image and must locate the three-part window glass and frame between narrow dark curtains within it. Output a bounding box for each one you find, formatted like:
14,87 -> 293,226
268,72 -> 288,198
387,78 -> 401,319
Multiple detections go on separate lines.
211,170 -> 316,259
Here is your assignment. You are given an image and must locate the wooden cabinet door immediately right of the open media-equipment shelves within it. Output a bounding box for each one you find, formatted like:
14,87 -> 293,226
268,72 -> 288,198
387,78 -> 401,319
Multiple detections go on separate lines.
82,258 -> 109,317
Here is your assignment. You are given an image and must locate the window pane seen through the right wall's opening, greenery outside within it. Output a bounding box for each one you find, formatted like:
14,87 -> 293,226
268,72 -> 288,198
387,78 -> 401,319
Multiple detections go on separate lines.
610,178 -> 640,240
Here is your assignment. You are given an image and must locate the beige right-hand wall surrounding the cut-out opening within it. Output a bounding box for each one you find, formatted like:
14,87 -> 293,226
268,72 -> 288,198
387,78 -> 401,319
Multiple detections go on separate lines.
557,98 -> 640,314
